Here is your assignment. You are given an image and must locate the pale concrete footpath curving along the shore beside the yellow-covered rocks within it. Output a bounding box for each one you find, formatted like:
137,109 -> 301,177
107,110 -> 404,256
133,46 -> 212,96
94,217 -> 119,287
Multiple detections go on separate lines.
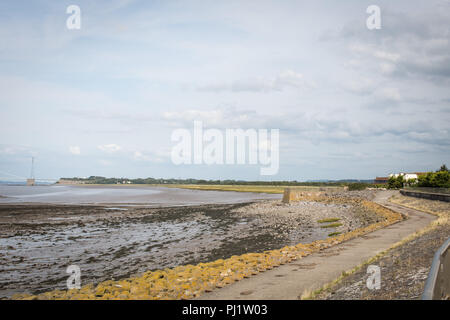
198,191 -> 436,300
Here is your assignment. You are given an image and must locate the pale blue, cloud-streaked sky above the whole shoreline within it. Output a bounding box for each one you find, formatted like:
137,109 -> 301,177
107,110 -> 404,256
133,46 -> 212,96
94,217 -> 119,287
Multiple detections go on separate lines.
0,0 -> 450,181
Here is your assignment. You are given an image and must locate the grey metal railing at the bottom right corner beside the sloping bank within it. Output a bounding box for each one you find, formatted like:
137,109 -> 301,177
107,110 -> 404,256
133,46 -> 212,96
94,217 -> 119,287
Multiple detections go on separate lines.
422,238 -> 450,300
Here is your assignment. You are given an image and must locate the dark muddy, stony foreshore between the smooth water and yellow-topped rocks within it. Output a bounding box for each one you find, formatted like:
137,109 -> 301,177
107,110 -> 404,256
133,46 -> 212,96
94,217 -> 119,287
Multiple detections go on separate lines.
0,196 -> 379,297
